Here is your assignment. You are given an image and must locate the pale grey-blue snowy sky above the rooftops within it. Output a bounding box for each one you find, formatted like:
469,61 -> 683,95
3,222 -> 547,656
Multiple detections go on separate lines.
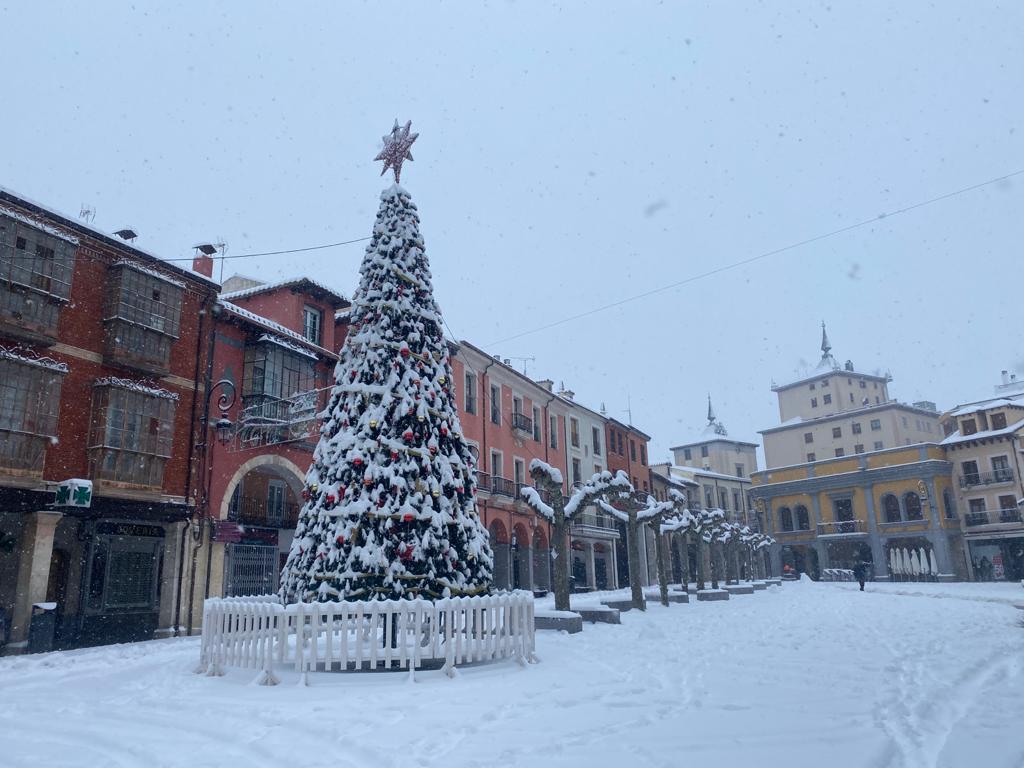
6,0 -> 1024,460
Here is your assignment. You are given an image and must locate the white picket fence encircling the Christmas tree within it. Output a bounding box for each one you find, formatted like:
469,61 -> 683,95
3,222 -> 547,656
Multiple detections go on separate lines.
196,592 -> 536,685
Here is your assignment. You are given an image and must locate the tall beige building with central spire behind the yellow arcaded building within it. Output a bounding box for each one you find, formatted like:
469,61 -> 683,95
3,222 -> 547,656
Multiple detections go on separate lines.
761,324 -> 941,468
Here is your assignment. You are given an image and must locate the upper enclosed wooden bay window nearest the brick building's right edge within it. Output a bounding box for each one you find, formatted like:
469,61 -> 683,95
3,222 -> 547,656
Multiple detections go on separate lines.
103,261 -> 184,373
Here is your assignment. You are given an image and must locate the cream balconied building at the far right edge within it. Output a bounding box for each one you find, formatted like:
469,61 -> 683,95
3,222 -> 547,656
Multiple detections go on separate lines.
942,371 -> 1024,581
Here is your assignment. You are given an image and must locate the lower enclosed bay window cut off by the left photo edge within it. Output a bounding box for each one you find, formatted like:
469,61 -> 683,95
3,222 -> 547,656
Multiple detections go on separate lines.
0,354 -> 68,477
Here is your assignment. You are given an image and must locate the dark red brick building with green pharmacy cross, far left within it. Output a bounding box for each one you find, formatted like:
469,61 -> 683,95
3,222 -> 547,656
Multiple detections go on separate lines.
0,190 -> 217,652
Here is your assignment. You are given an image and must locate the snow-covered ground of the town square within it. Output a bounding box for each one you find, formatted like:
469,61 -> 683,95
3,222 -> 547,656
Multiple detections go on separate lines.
0,583 -> 1024,768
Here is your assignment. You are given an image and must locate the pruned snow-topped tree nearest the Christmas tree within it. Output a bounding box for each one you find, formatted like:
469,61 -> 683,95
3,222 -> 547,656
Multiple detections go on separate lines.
520,459 -> 633,610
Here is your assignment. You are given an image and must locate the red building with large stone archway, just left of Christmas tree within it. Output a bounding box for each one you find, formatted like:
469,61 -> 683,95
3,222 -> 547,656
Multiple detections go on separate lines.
186,278 -> 349,627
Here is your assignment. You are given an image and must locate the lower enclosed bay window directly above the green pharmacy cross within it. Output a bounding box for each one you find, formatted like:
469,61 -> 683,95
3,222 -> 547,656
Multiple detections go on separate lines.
89,379 -> 177,489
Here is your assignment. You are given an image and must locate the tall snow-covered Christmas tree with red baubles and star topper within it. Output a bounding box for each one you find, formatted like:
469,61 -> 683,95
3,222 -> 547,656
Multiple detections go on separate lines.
281,123 -> 493,602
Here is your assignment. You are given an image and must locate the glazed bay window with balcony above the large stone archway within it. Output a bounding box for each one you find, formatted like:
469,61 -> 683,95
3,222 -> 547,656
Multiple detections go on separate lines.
239,334 -> 318,447
